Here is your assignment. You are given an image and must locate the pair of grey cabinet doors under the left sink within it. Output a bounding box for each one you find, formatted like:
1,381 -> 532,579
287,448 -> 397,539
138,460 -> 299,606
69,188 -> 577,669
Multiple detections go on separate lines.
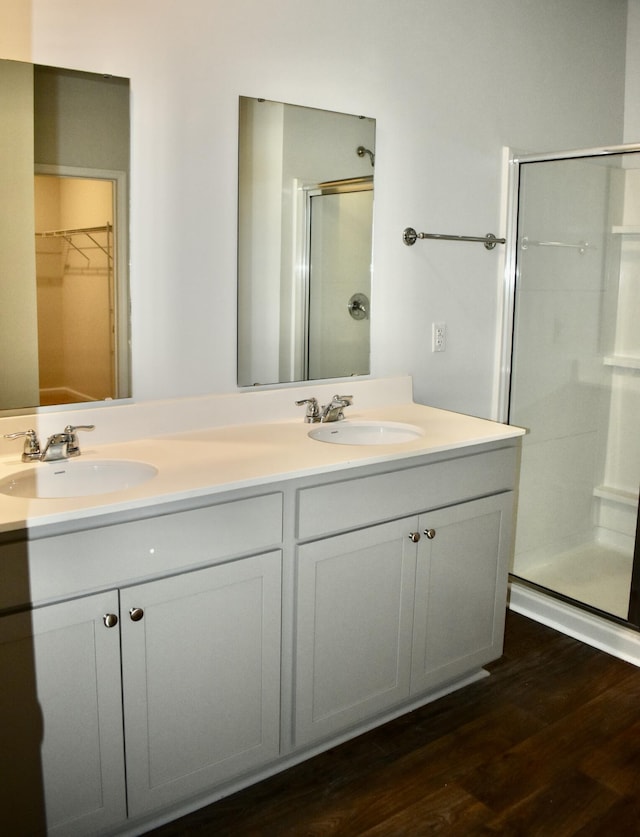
0,551 -> 281,837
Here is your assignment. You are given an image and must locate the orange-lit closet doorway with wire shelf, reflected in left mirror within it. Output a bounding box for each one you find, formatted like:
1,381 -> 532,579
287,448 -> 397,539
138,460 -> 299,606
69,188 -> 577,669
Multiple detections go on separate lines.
34,174 -> 117,406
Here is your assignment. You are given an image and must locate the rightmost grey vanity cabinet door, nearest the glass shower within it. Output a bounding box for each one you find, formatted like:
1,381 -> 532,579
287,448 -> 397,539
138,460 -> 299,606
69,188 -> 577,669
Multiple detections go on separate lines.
411,492 -> 513,694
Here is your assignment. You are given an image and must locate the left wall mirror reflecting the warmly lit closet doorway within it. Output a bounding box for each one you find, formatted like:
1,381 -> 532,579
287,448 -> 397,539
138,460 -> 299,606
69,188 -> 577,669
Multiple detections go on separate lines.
0,60 -> 131,411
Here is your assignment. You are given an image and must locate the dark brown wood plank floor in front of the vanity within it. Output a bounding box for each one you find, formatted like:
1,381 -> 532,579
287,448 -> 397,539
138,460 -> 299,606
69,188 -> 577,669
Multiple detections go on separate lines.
145,613 -> 640,837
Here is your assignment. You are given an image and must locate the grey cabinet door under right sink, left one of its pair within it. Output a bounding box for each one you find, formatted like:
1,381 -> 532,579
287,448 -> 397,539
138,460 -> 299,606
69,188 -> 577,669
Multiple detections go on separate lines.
295,518 -> 417,746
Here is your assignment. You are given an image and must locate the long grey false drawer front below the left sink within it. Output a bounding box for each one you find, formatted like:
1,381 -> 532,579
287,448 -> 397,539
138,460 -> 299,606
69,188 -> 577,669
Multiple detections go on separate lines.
0,492 -> 282,609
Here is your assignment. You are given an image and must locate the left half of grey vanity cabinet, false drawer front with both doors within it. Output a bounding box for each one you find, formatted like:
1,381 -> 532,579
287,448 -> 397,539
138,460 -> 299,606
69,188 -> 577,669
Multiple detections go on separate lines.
0,493 -> 282,837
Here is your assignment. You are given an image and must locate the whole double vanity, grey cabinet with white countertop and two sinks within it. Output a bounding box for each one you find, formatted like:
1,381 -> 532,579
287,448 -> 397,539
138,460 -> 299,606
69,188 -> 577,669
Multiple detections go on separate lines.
0,379 -> 522,837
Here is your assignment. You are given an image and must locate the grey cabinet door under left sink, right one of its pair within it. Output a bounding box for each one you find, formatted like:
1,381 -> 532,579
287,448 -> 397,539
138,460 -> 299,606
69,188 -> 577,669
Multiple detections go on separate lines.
120,552 -> 281,816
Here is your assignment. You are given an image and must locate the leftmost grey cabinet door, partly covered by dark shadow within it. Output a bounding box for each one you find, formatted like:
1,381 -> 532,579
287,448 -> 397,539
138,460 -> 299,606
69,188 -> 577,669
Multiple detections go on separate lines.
0,592 -> 126,837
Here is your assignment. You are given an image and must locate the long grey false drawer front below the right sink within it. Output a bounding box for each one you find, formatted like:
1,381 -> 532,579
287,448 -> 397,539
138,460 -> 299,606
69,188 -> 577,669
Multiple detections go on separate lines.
297,448 -> 516,539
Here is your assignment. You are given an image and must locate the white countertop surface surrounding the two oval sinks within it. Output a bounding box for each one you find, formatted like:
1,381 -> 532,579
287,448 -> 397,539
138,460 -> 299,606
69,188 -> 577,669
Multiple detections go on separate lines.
0,402 -> 524,532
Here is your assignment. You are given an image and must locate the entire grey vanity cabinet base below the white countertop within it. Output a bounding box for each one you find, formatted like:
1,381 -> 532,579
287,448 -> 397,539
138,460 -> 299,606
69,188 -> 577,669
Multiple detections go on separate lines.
0,434 -> 518,837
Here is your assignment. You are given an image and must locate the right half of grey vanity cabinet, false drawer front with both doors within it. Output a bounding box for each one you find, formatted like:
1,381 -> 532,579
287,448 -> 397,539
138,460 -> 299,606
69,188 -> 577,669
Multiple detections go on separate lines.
294,451 -> 513,746
